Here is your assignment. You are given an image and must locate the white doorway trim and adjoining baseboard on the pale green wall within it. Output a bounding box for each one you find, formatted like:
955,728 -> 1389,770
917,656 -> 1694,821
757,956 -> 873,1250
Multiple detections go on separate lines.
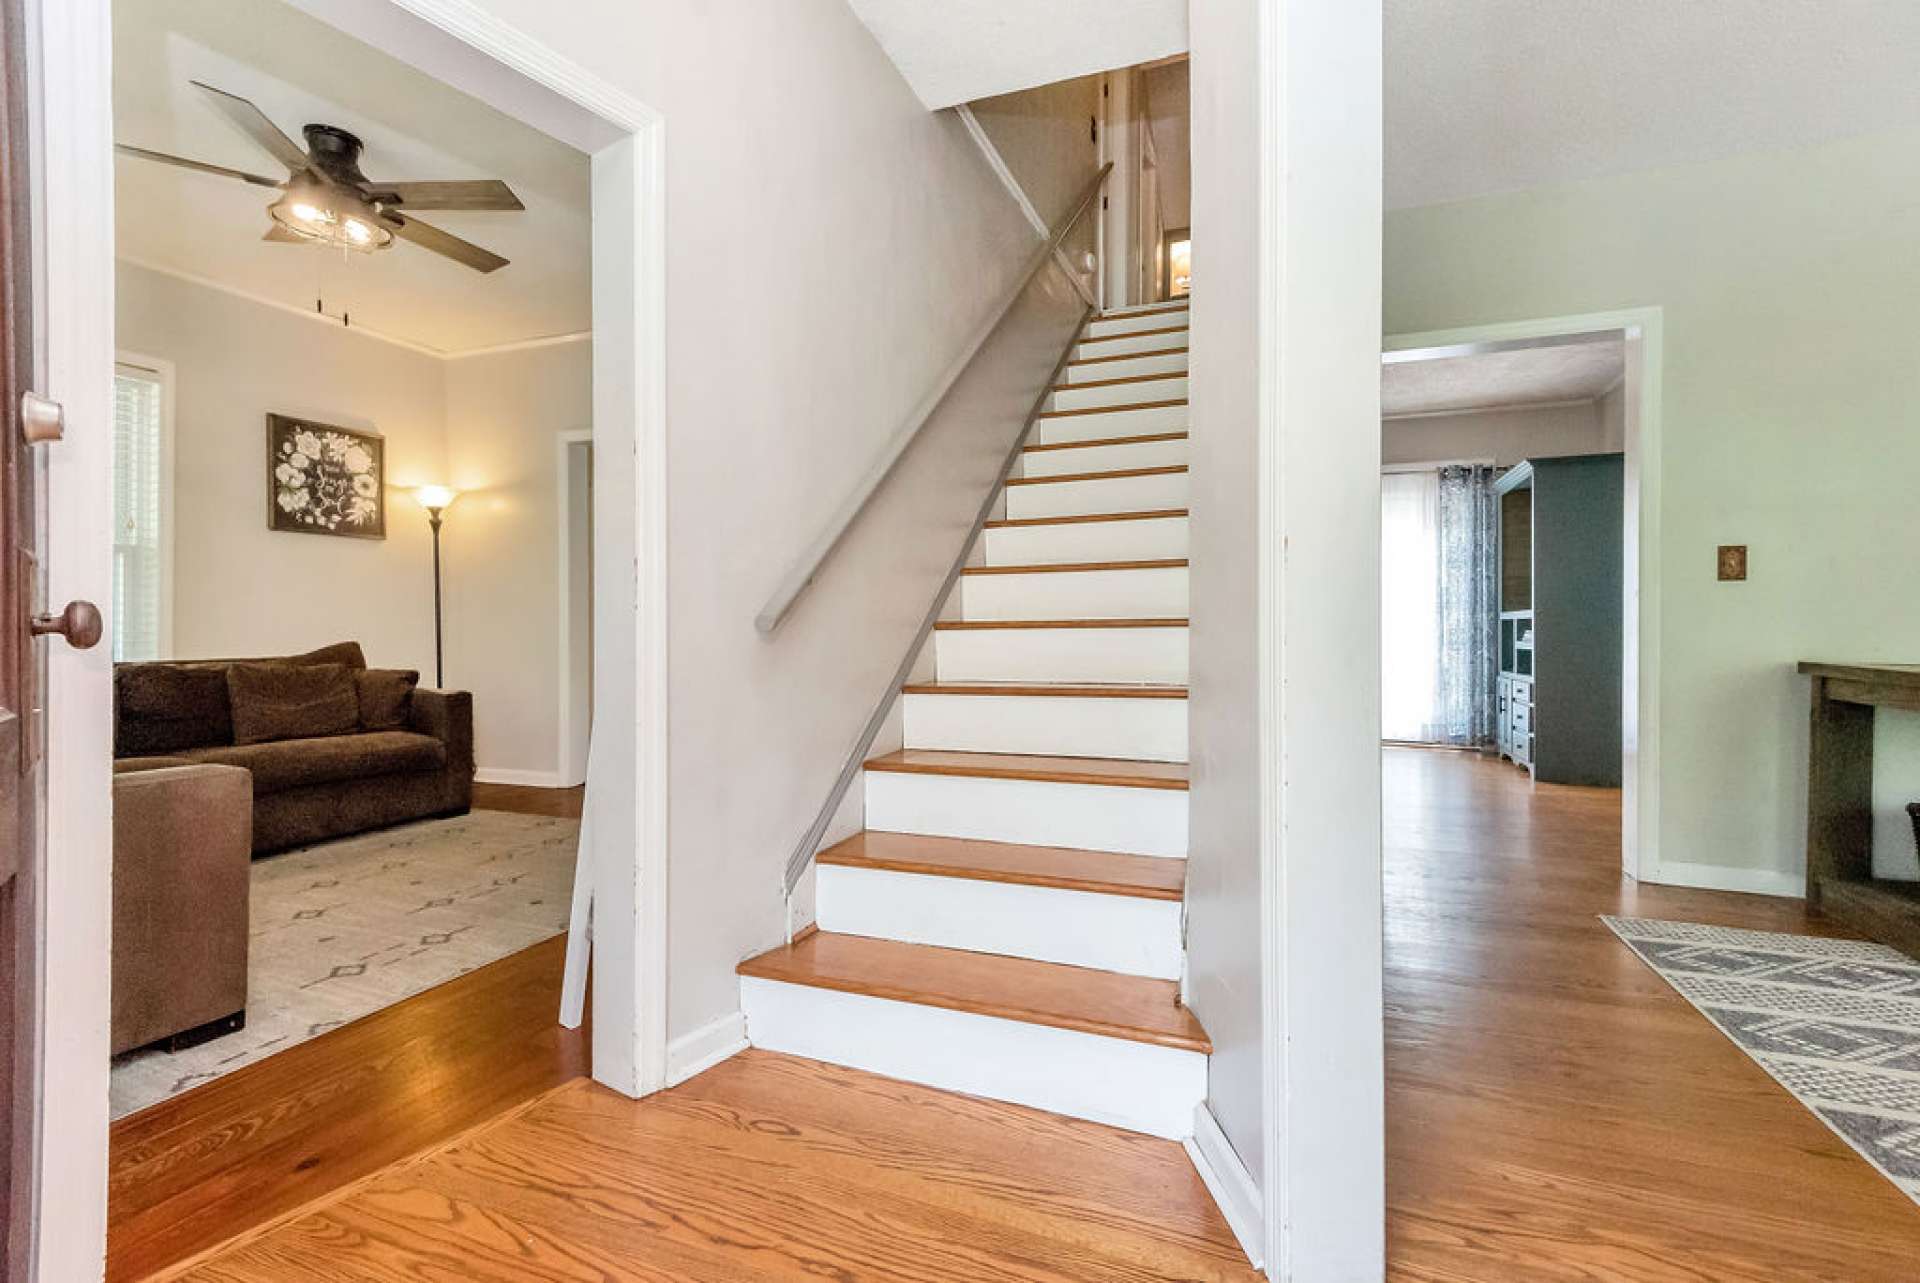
1380,307 -> 1666,895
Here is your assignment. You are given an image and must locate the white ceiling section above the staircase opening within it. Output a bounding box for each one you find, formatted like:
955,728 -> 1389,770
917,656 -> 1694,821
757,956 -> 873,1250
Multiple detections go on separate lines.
847,0 -> 1187,111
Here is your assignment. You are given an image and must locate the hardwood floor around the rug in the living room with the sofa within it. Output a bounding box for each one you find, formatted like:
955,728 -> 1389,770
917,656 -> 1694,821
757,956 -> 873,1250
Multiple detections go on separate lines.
106,786 -> 588,1283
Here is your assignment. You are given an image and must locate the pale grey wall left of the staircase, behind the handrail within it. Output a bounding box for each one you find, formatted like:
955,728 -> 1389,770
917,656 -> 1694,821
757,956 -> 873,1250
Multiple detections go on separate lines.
449,0 -> 1079,1035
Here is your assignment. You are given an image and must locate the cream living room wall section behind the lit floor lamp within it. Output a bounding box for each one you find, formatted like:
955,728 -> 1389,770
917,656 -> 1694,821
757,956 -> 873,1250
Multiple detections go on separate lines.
442,342 -> 593,784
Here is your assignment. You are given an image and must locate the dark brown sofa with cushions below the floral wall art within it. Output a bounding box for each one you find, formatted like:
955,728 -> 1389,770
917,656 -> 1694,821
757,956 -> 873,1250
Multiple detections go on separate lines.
113,642 -> 474,855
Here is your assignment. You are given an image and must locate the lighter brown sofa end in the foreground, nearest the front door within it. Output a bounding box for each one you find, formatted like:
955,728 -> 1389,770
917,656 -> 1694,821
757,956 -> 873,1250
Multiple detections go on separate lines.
113,766 -> 253,1056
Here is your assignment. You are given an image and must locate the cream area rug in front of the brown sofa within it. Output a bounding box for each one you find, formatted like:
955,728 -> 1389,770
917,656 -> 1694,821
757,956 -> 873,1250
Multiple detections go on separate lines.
111,811 -> 580,1118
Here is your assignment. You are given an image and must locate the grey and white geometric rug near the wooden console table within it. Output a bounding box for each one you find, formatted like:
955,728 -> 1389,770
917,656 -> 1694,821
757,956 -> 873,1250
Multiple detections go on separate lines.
1601,916 -> 1920,1206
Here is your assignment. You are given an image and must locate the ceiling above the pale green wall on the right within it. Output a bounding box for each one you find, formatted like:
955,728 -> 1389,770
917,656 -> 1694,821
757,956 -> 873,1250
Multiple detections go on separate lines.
1386,0 -> 1920,207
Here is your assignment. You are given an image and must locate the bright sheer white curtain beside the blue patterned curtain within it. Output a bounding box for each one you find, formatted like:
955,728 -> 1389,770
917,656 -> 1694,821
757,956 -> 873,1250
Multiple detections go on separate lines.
1380,472 -> 1442,743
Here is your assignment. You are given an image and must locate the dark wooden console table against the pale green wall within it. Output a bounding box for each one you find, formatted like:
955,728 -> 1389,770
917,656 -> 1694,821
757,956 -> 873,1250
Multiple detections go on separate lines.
1799,661 -> 1920,956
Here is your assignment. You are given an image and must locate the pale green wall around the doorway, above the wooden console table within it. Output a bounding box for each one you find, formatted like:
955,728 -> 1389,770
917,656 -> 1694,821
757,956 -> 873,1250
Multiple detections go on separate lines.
1386,129 -> 1920,891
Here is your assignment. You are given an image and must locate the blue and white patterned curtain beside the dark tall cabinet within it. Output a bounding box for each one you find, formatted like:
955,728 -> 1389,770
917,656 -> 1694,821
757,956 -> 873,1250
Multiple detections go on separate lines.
1432,463 -> 1500,747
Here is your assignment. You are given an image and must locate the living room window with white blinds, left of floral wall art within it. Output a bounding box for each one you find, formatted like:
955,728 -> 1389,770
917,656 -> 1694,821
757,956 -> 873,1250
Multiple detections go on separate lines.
108,359 -> 173,659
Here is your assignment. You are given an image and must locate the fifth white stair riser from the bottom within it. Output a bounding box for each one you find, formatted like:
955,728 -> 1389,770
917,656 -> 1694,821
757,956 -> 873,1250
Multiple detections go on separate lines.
933,628 -> 1187,686
